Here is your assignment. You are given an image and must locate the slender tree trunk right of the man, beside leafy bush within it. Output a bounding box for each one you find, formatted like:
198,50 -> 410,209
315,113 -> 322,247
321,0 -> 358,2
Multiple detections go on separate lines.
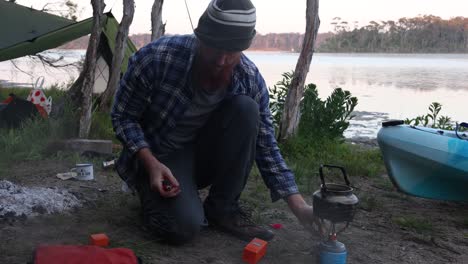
278,0 -> 320,141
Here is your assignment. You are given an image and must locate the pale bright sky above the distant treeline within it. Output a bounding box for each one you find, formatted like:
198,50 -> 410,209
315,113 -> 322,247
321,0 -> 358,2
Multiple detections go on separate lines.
16,0 -> 468,34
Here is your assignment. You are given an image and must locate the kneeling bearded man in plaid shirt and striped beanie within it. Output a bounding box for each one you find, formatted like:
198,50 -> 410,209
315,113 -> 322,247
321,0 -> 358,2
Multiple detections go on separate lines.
112,0 -> 312,244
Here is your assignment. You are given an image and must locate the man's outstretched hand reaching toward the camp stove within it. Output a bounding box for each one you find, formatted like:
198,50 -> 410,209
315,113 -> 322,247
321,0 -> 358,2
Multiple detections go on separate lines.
286,194 -> 317,234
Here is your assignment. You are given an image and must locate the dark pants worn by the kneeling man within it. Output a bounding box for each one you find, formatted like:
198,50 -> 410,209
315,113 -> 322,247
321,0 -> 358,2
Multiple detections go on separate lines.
136,95 -> 259,244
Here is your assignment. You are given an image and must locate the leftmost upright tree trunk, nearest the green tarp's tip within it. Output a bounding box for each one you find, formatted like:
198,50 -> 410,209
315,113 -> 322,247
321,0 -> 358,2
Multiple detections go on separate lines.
78,0 -> 105,138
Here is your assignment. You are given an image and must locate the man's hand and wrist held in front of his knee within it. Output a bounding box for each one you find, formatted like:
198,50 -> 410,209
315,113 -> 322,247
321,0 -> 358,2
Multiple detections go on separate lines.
137,148 -> 180,198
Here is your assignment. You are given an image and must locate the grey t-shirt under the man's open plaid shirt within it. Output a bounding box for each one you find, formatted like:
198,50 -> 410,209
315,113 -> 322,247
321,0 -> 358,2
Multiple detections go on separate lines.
157,87 -> 226,154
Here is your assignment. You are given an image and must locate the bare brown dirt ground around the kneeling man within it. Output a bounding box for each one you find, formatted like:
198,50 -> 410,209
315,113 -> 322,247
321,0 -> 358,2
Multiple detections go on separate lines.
0,160 -> 468,264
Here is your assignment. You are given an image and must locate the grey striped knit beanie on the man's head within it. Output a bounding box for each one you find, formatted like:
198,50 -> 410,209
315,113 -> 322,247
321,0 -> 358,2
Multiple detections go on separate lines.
195,0 -> 256,51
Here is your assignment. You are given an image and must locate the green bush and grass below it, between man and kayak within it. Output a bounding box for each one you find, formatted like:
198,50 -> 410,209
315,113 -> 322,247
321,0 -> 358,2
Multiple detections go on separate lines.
269,72 -> 376,192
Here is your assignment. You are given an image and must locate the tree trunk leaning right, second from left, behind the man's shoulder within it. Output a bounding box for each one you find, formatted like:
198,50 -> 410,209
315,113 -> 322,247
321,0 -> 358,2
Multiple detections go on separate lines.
99,0 -> 135,112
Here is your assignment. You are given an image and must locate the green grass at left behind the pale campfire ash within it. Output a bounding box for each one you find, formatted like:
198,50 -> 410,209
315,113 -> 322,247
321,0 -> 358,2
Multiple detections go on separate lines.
0,86 -> 116,175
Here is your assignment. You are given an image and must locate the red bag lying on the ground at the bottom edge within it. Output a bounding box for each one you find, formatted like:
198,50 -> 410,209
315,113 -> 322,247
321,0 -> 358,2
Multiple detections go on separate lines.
34,245 -> 139,264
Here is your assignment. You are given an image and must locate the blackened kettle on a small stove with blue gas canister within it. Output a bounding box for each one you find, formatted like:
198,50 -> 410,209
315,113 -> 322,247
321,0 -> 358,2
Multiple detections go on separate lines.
312,165 -> 359,264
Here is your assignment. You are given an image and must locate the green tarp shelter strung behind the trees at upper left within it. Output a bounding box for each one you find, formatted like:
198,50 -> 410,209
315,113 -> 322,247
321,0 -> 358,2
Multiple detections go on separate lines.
0,0 -> 137,73
